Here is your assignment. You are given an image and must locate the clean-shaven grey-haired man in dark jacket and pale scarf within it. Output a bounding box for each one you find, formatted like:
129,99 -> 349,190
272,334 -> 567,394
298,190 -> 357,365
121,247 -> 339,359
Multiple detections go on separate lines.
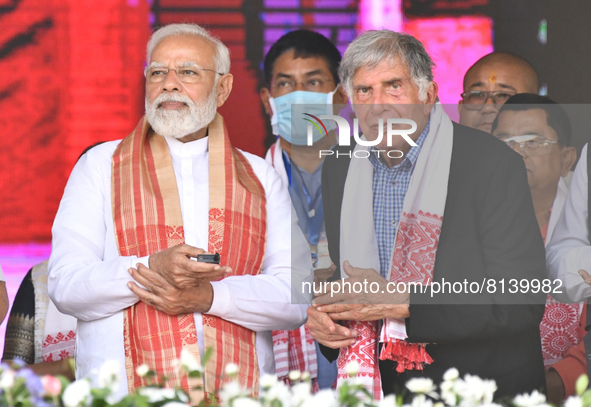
308,30 -> 545,397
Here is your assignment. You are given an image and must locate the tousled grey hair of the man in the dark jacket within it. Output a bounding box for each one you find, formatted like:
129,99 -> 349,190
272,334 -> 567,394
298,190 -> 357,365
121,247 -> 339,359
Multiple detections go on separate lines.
339,30 -> 435,102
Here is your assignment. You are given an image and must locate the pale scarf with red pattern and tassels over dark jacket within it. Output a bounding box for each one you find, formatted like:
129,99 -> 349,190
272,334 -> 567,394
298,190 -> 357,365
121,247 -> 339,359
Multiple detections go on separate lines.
337,103 -> 453,399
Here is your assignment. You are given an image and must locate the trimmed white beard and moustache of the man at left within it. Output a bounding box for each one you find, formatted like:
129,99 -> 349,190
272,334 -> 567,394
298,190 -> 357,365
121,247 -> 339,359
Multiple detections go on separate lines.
145,87 -> 217,139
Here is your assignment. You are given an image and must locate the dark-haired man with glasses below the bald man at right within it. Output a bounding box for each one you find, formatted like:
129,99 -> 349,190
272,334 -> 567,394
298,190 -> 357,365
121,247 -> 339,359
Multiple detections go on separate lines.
492,93 -> 587,405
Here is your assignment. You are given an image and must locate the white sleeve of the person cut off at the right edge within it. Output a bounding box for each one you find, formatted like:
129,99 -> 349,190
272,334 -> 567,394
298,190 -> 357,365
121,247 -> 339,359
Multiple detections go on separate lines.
546,146 -> 591,302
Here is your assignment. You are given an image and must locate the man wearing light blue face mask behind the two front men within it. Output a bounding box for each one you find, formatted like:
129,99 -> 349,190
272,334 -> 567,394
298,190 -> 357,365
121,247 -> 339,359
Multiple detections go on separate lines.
260,30 -> 347,388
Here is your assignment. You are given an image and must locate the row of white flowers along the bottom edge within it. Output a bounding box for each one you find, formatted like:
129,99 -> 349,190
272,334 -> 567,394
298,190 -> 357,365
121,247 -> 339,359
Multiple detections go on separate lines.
0,351 -> 591,407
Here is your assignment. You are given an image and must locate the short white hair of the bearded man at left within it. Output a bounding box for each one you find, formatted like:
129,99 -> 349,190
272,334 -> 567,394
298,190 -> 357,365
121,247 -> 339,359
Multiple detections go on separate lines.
146,24 -> 230,74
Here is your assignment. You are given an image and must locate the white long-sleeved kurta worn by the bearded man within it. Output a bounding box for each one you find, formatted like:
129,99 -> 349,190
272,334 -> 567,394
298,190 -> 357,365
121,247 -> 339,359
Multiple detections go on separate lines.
49,138 -> 313,395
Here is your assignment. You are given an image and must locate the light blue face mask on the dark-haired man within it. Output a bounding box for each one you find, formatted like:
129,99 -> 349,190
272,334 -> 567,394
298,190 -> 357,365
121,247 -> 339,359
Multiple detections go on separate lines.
269,85 -> 339,146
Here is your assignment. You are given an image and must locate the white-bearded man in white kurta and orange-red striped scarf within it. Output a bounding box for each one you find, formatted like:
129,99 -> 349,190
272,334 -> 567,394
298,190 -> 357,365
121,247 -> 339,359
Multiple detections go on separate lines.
49,24 -> 312,404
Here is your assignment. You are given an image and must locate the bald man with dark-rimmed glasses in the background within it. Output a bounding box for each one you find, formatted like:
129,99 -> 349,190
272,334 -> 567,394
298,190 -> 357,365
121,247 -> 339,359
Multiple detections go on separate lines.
458,52 -> 538,133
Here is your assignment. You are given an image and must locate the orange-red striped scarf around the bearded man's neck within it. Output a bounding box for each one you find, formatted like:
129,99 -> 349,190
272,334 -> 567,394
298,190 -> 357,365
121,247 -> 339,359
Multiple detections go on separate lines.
111,114 -> 267,405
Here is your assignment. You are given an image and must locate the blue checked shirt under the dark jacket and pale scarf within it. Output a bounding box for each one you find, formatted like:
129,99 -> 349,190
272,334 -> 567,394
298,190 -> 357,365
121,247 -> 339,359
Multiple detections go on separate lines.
369,119 -> 431,278
